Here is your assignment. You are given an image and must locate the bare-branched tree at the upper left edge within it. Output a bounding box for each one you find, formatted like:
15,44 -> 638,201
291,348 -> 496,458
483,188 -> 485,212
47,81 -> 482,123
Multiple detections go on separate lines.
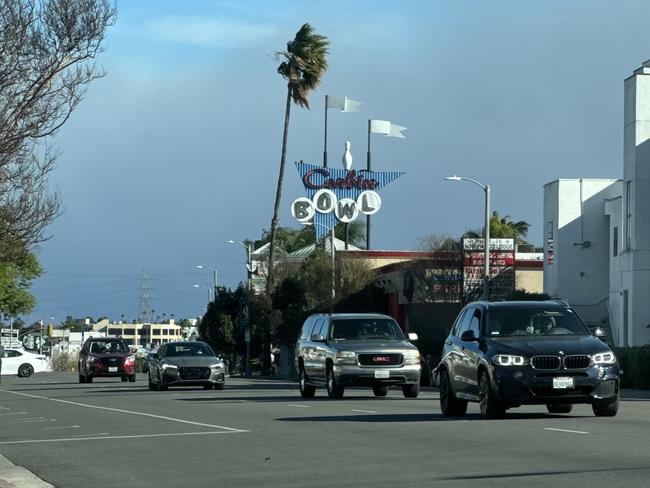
0,0 -> 115,263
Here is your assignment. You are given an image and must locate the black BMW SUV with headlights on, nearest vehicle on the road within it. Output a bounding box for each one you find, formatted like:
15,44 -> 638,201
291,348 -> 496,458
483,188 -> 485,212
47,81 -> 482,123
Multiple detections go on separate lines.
434,300 -> 619,418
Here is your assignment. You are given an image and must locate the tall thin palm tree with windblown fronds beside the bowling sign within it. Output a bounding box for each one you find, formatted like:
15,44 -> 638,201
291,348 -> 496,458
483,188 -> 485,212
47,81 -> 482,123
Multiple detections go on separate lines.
266,24 -> 329,293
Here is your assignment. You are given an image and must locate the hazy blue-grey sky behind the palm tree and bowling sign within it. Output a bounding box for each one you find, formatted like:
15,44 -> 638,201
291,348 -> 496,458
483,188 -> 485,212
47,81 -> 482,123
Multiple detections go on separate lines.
26,0 -> 650,323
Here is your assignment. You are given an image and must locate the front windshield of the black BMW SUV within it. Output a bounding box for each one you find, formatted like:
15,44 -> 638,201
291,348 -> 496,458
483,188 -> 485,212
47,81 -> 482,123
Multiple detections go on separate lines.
485,307 -> 589,337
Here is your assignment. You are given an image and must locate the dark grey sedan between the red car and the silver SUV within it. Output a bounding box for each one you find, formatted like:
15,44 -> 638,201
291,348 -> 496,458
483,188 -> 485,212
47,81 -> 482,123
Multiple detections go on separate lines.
149,341 -> 226,390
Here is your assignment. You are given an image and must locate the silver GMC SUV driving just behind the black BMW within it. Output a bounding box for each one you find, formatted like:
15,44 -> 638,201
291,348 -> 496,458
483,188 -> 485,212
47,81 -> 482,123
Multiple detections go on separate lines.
295,314 -> 420,398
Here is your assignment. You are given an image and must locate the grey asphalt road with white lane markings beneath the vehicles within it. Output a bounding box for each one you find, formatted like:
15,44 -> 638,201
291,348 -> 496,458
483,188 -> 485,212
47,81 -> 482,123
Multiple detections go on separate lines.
0,373 -> 650,488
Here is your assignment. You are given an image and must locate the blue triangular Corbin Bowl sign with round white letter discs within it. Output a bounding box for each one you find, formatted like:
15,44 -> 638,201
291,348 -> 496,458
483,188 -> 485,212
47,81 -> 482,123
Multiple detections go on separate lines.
291,161 -> 404,241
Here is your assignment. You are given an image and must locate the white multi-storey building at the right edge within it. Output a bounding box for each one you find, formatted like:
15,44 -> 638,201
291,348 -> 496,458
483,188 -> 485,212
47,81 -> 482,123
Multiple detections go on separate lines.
544,61 -> 650,346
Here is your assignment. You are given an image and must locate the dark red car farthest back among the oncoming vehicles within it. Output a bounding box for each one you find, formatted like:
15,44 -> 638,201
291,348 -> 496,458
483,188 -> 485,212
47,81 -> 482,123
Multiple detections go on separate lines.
79,337 -> 135,383
